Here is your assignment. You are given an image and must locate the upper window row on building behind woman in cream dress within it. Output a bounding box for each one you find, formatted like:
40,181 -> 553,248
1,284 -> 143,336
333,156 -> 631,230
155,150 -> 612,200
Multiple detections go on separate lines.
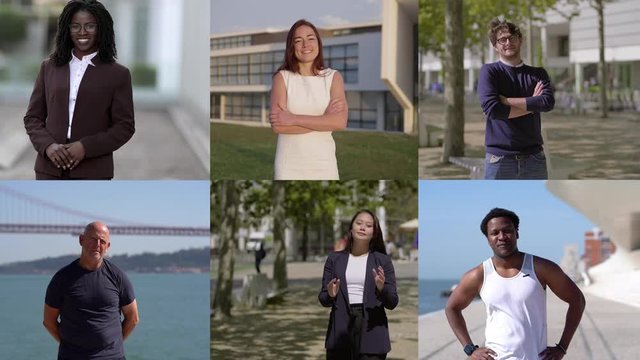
211,44 -> 358,85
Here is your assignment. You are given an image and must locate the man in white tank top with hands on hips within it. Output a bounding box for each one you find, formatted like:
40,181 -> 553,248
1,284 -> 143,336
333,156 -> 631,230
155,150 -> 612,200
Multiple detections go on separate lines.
445,208 -> 585,360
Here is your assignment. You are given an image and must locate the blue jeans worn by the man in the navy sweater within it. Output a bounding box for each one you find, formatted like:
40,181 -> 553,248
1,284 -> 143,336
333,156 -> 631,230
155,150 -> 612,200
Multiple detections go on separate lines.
484,151 -> 547,180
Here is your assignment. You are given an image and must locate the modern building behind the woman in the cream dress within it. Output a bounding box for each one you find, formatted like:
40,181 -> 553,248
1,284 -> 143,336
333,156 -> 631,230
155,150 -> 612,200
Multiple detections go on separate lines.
210,0 -> 418,133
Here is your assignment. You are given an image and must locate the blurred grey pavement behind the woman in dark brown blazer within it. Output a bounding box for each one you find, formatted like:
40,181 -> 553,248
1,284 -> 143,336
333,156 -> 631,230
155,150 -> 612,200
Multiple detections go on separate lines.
0,104 -> 209,180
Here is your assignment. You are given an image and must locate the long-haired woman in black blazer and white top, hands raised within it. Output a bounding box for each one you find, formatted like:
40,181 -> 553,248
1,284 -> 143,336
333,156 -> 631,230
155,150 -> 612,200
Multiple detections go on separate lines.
318,210 -> 398,360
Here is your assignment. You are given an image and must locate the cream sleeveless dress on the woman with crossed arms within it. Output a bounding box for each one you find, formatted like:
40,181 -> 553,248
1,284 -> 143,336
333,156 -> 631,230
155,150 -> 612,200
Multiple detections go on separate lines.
274,69 -> 339,180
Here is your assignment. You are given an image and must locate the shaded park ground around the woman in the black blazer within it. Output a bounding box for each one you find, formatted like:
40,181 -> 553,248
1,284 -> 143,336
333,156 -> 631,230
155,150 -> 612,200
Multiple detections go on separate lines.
211,262 -> 418,360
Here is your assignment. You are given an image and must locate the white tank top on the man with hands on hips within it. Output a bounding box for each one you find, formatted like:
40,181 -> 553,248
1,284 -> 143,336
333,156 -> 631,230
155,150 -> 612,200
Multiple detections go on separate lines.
480,254 -> 547,360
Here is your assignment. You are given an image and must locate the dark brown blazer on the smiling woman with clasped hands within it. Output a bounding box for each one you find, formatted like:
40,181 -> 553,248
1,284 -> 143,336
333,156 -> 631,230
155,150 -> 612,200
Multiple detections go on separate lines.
24,56 -> 135,178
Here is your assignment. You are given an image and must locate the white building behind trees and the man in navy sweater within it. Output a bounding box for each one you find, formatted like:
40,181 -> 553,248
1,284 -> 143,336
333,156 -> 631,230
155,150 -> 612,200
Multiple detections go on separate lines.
421,0 -> 640,105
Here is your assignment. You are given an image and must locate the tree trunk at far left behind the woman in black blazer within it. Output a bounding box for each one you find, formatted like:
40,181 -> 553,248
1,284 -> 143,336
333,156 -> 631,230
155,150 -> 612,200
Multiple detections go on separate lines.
213,181 -> 238,317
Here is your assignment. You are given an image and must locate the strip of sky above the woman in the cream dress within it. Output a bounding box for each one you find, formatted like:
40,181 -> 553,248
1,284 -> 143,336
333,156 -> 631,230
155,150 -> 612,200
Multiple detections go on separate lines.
210,0 -> 382,34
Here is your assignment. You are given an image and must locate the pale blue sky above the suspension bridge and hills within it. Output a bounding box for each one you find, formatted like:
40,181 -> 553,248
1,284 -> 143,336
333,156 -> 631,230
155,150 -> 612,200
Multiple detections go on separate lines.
0,181 -> 210,264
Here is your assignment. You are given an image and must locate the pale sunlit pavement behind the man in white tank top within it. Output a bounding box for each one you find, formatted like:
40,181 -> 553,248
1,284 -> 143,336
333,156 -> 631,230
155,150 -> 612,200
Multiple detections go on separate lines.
419,293 -> 640,360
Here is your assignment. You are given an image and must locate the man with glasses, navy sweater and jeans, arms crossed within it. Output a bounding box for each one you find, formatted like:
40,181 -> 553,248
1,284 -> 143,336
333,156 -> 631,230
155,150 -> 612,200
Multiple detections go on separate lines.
478,19 -> 555,179
